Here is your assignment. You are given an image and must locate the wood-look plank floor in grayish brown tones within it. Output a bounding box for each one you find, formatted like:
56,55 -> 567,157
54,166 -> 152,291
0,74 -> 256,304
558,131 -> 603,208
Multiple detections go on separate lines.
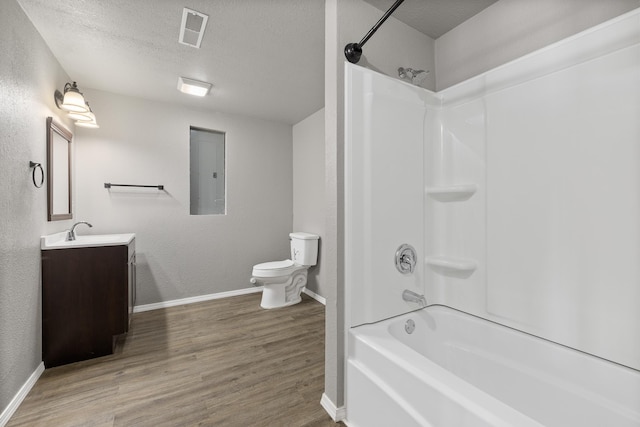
7,294 -> 342,427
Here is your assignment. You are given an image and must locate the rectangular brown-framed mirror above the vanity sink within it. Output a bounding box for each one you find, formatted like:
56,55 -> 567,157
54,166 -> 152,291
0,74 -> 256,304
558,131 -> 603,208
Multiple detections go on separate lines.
47,117 -> 73,221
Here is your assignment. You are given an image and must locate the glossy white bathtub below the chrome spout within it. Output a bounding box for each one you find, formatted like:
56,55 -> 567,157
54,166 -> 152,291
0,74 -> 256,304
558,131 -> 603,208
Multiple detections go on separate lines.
345,306 -> 640,427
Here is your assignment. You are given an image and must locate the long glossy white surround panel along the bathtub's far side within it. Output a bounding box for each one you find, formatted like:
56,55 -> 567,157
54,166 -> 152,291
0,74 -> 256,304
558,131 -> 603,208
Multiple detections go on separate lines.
426,10 -> 640,369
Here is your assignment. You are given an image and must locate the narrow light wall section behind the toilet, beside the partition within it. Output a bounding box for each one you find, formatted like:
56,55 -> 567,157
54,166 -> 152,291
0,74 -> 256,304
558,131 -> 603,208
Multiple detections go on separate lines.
293,108 -> 327,297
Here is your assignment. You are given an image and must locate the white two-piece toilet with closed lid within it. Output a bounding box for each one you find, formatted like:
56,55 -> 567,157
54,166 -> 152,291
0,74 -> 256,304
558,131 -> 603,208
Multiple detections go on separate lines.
250,232 -> 320,308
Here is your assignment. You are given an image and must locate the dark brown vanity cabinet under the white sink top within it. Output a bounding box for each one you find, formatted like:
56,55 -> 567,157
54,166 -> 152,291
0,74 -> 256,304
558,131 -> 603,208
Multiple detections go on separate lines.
41,239 -> 136,368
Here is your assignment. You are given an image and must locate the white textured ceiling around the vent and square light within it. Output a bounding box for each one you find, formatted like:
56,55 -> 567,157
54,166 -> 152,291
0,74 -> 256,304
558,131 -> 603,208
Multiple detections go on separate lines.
17,0 -> 494,124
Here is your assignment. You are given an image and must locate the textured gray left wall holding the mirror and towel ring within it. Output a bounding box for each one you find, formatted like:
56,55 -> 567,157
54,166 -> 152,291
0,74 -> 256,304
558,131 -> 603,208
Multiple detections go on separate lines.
0,0 -> 75,413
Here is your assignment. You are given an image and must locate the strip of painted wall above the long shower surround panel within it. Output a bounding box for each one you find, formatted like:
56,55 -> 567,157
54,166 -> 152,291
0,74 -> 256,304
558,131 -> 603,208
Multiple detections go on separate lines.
435,0 -> 640,90
